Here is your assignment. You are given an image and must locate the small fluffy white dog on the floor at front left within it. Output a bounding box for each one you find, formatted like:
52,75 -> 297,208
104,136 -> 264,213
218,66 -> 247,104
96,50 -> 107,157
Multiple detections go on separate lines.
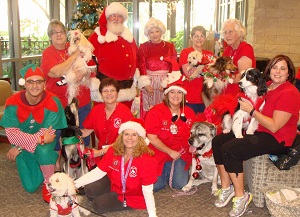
47,173 -> 90,217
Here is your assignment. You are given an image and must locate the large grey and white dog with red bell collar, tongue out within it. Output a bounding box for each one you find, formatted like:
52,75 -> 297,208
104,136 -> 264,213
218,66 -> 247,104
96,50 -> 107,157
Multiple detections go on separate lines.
182,122 -> 218,194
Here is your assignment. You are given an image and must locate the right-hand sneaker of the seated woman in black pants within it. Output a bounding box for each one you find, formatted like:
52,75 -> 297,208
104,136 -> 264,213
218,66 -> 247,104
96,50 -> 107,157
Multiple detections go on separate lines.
229,192 -> 252,217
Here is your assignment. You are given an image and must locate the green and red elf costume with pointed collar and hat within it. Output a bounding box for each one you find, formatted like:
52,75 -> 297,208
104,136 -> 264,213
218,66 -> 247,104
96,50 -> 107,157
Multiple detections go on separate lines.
0,65 -> 67,198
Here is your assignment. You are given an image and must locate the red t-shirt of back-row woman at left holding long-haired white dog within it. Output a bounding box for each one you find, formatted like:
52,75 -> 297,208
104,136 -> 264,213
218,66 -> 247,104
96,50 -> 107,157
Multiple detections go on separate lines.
41,43 -> 91,108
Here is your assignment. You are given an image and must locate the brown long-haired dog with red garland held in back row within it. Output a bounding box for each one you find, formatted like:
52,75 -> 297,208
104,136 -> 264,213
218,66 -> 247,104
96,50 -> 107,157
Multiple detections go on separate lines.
202,56 -> 237,107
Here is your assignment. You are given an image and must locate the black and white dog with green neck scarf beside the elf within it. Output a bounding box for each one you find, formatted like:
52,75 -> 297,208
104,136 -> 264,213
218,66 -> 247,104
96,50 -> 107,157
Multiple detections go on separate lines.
61,98 -> 88,179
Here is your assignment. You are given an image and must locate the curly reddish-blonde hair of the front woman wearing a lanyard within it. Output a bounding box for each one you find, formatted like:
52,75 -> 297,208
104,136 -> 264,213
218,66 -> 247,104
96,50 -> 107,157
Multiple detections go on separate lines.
112,132 -> 154,158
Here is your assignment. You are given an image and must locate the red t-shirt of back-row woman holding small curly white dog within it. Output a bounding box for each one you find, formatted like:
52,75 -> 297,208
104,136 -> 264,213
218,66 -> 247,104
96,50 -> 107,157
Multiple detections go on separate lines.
179,47 -> 214,104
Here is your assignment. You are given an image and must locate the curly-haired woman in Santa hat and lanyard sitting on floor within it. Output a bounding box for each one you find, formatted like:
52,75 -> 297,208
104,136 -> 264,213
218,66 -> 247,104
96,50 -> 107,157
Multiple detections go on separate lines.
75,119 -> 157,217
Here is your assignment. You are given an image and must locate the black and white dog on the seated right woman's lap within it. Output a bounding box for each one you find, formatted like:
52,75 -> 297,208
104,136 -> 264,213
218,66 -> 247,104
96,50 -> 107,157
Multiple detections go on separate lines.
223,68 -> 267,138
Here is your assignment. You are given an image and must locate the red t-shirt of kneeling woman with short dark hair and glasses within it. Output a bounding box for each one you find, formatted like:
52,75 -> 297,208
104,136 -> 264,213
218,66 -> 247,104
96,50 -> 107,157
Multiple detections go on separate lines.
83,102 -> 133,150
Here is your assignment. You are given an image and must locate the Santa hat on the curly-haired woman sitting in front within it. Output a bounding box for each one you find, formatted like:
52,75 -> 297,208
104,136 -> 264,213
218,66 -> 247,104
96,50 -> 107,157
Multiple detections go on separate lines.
118,118 -> 150,145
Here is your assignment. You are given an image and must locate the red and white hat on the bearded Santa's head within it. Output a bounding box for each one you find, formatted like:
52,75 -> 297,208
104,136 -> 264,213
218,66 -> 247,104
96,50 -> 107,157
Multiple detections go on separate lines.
98,2 -> 128,35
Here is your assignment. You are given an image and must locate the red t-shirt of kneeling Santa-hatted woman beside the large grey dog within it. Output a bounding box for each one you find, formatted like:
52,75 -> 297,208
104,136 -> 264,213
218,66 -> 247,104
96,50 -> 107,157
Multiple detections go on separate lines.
145,103 -> 196,175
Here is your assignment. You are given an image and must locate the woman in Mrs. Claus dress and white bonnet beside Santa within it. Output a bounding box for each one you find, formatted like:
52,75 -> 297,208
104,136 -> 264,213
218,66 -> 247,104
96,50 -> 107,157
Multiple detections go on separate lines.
138,17 -> 177,118
